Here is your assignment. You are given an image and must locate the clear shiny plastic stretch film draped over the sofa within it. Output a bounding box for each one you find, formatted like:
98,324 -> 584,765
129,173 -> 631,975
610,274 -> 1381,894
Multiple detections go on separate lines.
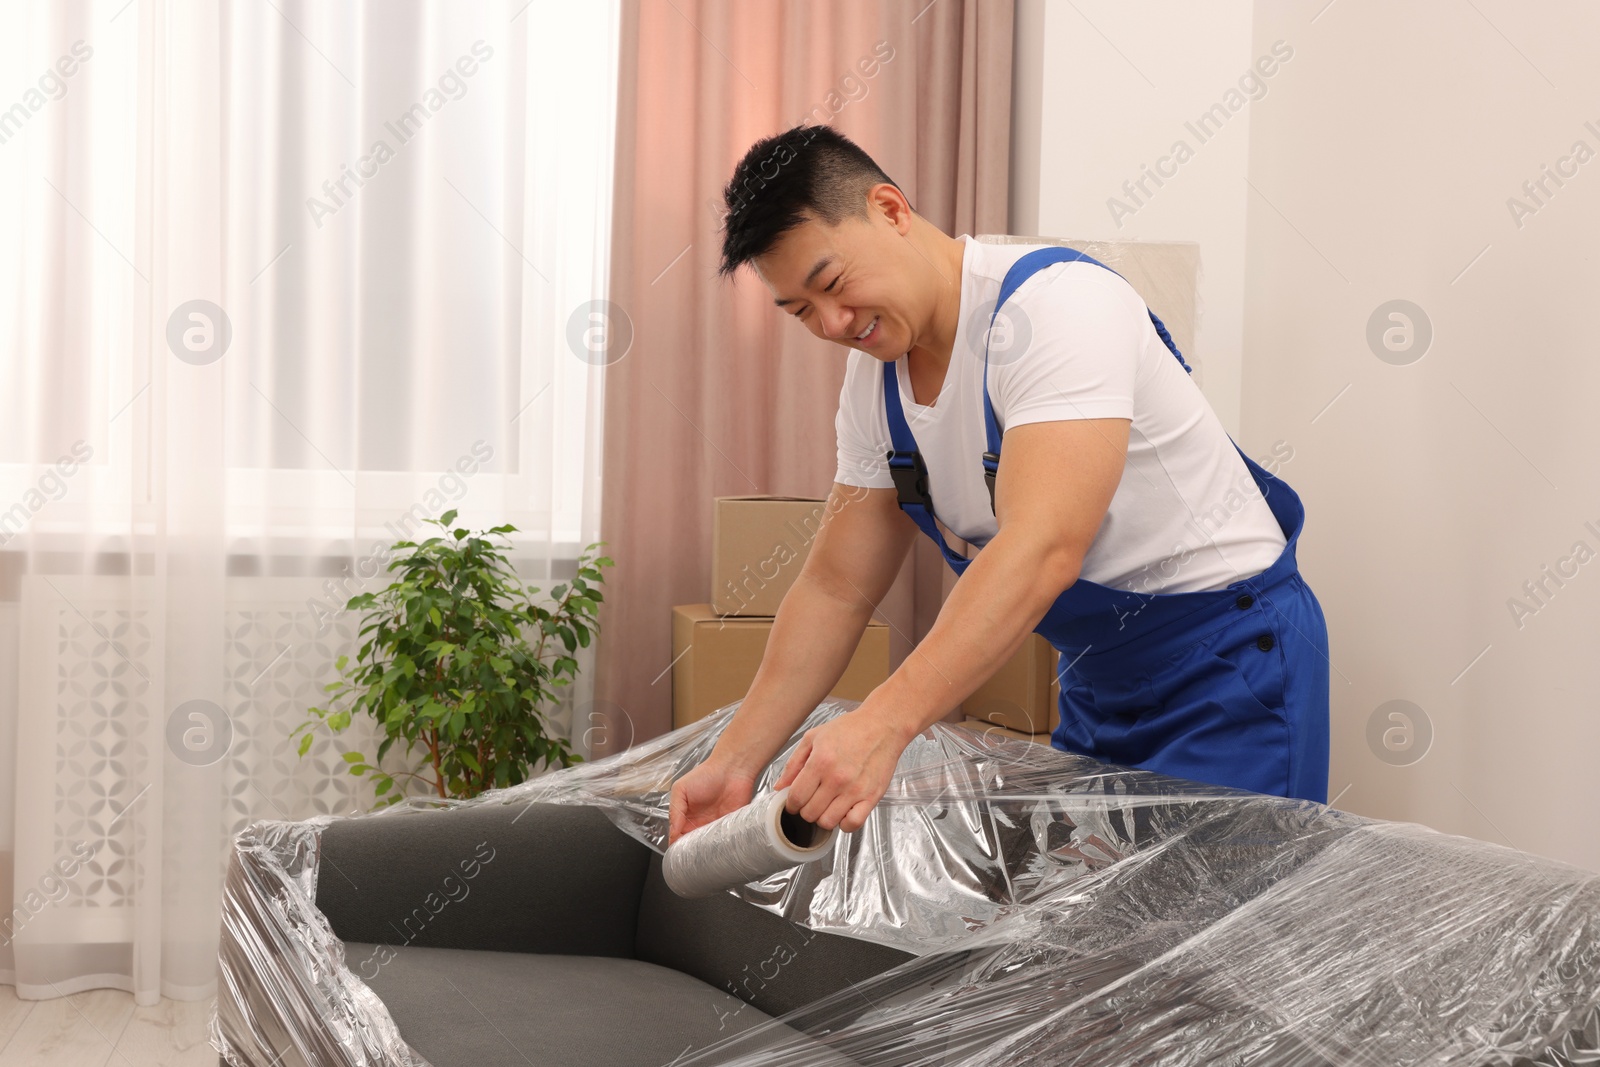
211,701 -> 1600,1067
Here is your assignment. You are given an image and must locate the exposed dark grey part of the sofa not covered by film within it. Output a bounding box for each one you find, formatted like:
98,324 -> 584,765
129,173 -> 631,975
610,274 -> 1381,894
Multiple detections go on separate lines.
305,803 -> 912,1067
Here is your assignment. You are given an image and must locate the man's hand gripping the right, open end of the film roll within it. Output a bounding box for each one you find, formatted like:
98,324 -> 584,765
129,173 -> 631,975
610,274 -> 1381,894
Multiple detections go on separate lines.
773,699 -> 910,833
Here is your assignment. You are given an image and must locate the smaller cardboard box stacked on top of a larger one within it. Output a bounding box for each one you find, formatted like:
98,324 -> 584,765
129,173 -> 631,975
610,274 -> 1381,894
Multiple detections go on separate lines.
710,496 -> 827,616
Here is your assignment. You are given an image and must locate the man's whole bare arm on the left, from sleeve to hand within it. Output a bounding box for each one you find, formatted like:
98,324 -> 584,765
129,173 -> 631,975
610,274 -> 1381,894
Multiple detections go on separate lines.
669,482 -> 917,840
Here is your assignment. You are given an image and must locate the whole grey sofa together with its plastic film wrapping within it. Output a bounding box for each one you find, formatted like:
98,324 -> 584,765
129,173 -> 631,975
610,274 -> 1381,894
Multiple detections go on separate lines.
211,701 -> 1600,1067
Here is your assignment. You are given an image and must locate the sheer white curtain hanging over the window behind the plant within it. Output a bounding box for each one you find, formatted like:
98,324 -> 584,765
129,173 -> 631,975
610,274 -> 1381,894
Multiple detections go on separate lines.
0,0 -> 618,1003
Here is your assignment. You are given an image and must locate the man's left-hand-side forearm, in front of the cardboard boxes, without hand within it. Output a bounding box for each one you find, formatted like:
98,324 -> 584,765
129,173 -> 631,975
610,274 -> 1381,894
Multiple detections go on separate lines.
712,573 -> 872,776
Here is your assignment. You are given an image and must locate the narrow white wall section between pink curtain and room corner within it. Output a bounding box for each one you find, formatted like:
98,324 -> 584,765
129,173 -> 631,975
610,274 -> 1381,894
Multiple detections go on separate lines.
1011,0 -> 1260,430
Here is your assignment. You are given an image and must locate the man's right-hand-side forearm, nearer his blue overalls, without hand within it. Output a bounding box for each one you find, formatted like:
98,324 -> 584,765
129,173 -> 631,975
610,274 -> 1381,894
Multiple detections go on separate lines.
862,531 -> 1082,744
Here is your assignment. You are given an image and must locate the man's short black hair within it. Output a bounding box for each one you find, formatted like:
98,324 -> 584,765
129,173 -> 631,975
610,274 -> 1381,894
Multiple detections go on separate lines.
717,125 -> 906,275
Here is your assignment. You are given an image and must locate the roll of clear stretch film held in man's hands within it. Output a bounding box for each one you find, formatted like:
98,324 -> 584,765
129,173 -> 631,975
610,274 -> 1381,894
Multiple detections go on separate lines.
661,789 -> 834,897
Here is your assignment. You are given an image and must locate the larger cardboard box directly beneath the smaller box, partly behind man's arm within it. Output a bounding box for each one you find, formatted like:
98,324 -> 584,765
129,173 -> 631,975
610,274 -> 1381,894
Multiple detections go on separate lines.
672,605 -> 890,728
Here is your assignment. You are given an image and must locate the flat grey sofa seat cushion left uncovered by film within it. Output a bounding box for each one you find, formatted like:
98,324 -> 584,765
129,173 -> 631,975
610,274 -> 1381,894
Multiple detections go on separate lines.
346,944 -> 848,1067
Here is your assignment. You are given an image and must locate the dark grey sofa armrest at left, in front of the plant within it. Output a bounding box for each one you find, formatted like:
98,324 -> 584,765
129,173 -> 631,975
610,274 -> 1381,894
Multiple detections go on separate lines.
317,803 -> 651,957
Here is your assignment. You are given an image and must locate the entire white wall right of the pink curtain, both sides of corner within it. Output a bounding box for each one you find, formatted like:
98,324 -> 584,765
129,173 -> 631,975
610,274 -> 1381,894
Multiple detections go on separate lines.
1013,0 -> 1600,869
